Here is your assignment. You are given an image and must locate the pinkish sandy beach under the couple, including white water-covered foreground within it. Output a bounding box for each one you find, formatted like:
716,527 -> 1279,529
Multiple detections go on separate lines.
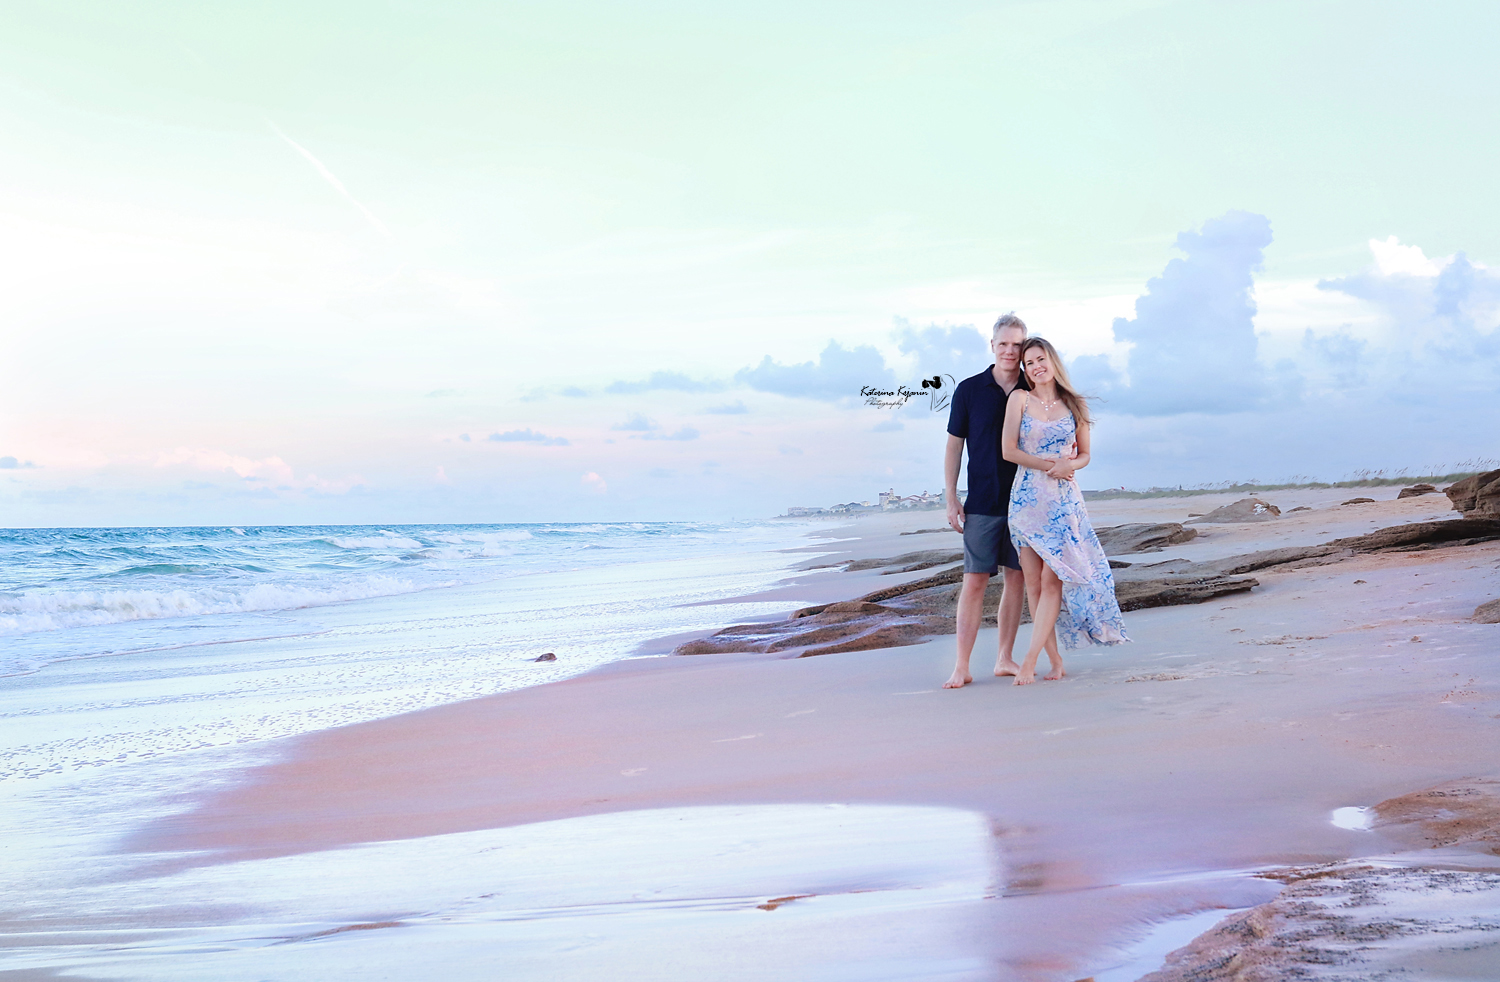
8,487 -> 1500,982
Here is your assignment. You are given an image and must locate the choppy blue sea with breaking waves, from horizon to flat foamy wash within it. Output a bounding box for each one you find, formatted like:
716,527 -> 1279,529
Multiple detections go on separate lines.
0,522 -> 792,648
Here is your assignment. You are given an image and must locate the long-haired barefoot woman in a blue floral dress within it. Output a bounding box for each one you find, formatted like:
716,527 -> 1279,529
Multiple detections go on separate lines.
1001,337 -> 1130,685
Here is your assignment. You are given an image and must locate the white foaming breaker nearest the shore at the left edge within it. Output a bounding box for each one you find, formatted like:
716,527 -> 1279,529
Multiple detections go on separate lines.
0,576 -> 426,634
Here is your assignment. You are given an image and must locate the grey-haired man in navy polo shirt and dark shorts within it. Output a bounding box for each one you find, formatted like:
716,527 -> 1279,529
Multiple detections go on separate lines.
944,313 -> 1026,688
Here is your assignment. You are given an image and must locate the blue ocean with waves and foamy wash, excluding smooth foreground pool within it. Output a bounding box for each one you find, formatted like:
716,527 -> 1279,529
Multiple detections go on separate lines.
0,522 -> 818,781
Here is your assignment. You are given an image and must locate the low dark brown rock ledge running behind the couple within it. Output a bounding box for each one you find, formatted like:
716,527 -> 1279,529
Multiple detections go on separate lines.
672,519 -> 1500,658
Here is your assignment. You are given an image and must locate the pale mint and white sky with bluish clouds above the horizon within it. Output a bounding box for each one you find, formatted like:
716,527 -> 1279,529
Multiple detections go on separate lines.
0,0 -> 1500,526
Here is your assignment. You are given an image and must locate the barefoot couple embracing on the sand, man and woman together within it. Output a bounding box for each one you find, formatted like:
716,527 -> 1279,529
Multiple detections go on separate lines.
944,313 -> 1130,688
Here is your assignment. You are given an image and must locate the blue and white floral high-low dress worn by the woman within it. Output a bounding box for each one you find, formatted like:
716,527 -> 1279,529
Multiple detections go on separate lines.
1008,412 -> 1130,651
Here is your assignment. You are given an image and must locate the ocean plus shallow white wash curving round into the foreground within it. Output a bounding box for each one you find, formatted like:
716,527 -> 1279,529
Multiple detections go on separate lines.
0,519 -> 995,982
